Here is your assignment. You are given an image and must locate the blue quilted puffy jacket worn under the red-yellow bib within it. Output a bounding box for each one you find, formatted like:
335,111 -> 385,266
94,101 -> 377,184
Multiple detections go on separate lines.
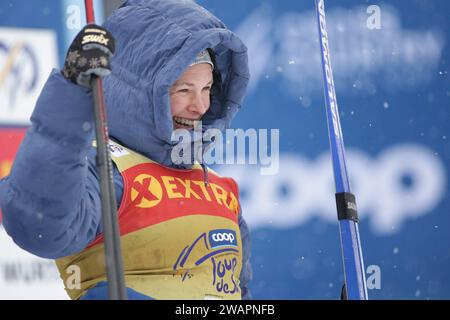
0,0 -> 251,298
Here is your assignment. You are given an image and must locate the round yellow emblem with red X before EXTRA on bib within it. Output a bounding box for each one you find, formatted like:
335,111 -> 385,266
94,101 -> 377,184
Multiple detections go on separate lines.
131,174 -> 163,208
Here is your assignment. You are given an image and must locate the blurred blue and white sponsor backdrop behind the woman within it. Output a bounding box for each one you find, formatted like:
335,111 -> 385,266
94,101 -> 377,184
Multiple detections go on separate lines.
0,0 -> 450,299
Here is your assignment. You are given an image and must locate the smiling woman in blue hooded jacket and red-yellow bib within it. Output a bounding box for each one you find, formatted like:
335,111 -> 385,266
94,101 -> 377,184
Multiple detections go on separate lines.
0,0 -> 251,300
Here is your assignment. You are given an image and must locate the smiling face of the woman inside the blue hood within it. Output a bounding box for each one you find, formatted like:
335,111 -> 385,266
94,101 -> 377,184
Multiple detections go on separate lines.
169,63 -> 213,129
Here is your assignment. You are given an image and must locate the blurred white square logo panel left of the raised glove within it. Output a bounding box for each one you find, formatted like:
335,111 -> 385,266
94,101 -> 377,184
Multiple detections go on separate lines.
0,28 -> 57,125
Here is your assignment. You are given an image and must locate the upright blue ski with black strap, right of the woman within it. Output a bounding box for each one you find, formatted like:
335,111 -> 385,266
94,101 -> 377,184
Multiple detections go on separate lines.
315,0 -> 368,300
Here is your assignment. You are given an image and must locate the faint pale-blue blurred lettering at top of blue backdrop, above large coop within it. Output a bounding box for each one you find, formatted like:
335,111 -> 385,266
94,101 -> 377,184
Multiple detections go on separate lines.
236,4 -> 446,95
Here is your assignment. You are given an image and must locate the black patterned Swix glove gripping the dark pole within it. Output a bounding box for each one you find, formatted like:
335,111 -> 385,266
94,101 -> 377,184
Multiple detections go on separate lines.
62,24 -> 115,88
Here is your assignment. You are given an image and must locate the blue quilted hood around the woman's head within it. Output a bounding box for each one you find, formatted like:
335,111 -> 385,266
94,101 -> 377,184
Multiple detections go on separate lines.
104,0 -> 249,167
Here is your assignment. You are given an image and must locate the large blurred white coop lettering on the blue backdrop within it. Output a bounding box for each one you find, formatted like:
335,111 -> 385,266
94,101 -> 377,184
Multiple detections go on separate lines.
221,143 -> 448,234
